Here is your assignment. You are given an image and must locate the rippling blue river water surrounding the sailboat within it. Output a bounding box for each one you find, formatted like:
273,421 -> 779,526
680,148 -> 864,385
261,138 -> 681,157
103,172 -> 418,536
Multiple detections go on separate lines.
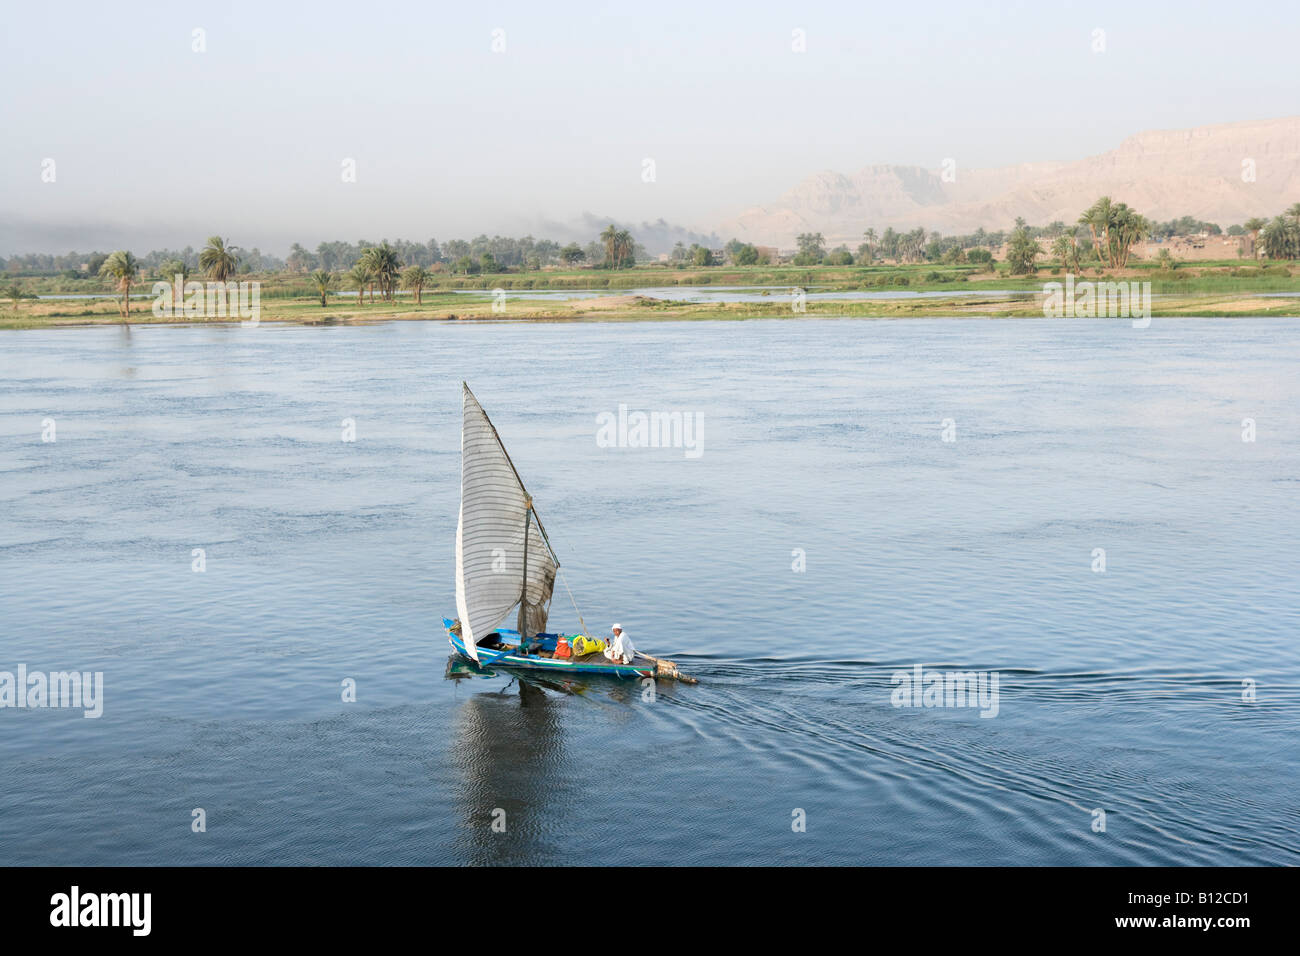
0,319 -> 1300,865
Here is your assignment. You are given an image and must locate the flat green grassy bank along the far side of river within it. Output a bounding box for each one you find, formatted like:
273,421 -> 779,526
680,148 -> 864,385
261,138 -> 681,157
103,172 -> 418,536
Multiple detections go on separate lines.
0,261 -> 1300,329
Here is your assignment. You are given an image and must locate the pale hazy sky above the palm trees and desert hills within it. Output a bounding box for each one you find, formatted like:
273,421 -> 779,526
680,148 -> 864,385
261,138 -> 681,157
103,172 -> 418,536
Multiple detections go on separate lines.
0,0 -> 1300,255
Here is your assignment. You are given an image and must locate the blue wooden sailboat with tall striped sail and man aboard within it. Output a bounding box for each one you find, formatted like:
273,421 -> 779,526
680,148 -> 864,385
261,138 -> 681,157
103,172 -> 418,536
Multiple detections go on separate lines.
442,382 -> 697,683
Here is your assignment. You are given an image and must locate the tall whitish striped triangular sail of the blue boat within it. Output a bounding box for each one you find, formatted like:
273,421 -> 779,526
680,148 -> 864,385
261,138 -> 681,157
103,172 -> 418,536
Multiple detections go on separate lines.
456,385 -> 555,661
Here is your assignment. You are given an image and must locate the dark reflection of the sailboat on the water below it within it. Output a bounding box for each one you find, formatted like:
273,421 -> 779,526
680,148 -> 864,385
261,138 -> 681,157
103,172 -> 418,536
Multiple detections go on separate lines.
445,654 -> 641,866
